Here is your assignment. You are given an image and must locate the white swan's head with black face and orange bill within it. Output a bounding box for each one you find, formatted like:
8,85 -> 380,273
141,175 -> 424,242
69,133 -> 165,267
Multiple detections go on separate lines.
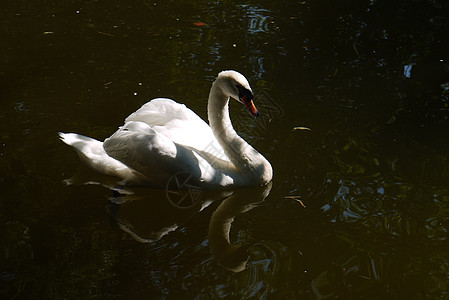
216,71 -> 259,118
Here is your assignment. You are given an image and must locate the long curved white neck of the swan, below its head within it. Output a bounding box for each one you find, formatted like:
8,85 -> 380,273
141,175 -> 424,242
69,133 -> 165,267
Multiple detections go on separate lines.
208,81 -> 273,185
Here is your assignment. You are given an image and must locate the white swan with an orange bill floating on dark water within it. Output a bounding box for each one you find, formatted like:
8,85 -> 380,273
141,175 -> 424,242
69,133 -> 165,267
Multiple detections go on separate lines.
59,71 -> 273,189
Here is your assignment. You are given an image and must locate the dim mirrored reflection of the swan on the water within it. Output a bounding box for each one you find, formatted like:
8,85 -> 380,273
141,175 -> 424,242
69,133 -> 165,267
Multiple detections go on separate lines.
110,183 -> 272,272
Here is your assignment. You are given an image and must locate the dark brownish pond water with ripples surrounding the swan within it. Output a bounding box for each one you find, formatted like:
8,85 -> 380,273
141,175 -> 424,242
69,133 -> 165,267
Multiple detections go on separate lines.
0,0 -> 449,299
